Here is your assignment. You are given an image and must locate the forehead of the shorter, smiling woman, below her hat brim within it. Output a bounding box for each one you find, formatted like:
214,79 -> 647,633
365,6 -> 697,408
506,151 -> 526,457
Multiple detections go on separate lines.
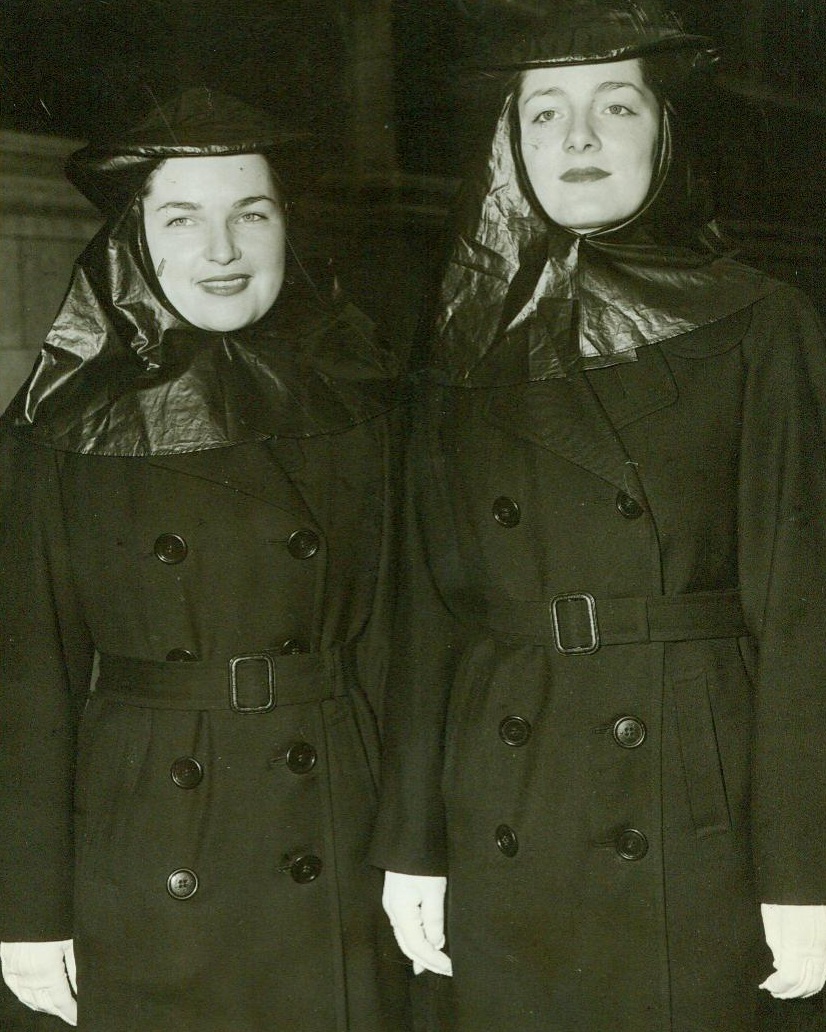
146,154 -> 276,203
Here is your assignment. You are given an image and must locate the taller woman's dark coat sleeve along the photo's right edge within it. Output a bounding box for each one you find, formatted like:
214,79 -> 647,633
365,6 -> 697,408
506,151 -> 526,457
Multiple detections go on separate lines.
738,289 -> 826,904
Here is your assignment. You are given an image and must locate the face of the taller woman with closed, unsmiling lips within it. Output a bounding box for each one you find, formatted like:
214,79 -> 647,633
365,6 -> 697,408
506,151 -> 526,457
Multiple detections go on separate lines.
518,60 -> 660,233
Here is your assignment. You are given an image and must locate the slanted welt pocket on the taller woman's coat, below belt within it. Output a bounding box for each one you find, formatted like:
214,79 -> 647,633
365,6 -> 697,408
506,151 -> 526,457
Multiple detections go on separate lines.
673,673 -> 731,836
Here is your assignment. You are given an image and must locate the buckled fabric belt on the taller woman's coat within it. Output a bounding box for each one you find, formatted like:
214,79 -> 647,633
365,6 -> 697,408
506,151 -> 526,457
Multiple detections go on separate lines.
487,591 -> 749,655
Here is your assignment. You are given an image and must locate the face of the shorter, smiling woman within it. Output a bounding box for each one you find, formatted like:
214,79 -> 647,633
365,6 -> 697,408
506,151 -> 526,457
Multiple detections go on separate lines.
144,154 -> 286,332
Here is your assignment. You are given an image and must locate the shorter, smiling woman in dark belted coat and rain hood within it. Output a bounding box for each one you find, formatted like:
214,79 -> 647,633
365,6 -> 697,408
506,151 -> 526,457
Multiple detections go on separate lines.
0,90 -> 407,1032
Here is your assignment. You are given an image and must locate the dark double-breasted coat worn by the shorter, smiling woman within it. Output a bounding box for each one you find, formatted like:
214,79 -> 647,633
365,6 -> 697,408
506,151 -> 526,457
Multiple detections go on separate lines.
0,415 -> 407,1032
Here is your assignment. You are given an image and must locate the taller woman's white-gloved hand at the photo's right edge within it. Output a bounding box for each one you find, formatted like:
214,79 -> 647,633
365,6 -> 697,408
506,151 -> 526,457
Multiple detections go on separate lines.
760,903 -> 826,1000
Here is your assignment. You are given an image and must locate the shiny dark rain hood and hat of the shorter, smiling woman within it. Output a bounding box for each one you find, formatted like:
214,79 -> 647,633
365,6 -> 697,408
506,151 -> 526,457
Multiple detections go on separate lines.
2,89 -> 395,455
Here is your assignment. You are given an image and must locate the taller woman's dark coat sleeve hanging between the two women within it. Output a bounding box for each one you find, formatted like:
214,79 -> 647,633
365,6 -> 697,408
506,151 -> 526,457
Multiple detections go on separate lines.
370,390 -> 462,875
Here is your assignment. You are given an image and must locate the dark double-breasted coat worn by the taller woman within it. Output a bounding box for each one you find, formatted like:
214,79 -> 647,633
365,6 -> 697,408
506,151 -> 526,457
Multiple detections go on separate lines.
372,287 -> 826,1032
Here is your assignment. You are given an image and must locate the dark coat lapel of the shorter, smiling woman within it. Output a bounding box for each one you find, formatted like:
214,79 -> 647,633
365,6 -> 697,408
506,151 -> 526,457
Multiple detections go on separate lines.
150,441 -> 314,522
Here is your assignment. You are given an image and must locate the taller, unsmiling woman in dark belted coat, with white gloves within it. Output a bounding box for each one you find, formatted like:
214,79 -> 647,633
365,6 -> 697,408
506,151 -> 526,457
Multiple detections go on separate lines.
371,0 -> 826,1032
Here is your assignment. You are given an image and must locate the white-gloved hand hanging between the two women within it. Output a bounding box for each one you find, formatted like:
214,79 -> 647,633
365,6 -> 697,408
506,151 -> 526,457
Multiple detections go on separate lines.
382,871 -> 453,975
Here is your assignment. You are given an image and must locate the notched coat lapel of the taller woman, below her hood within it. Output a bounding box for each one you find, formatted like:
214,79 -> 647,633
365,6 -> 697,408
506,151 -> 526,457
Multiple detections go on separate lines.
486,348 -> 677,503
